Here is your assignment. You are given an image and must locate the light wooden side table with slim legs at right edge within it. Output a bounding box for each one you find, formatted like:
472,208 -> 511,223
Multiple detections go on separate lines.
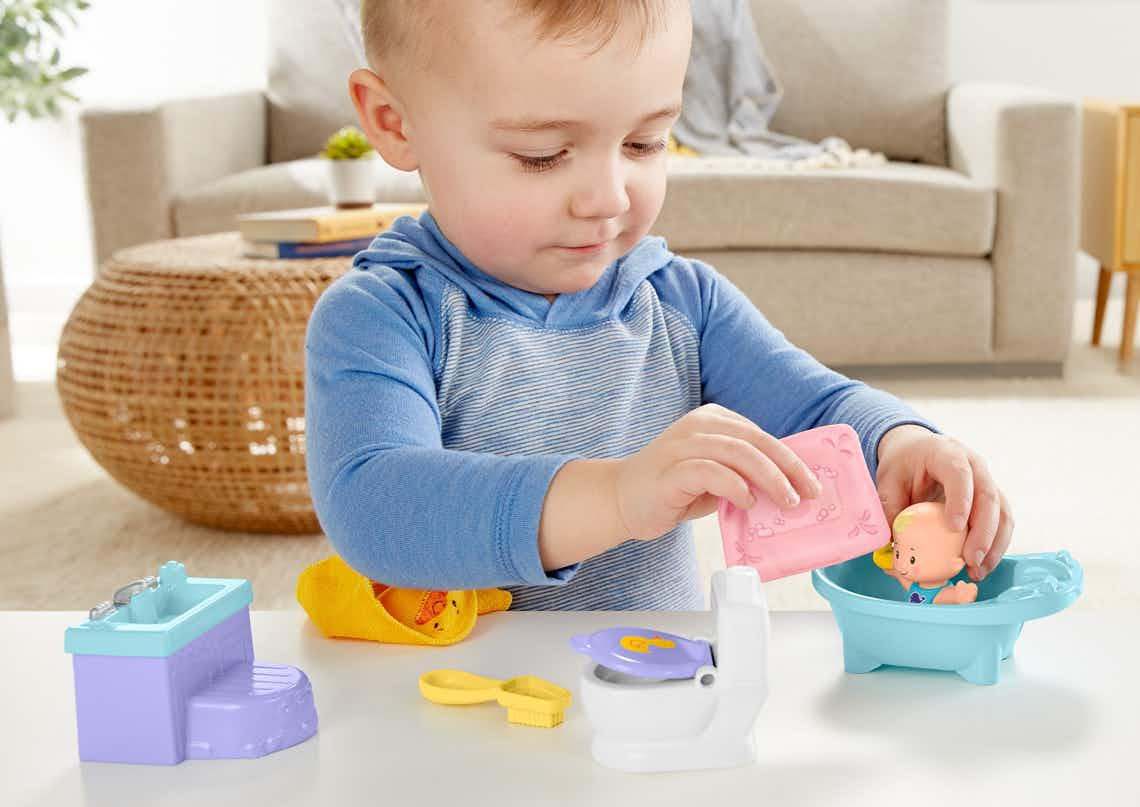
1081,99 -> 1140,369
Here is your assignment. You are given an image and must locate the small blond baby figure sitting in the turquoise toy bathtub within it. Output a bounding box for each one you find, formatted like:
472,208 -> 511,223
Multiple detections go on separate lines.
874,502 -> 978,605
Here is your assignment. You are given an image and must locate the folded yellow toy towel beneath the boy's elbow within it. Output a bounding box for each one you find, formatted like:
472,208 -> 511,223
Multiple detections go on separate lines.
296,555 -> 511,645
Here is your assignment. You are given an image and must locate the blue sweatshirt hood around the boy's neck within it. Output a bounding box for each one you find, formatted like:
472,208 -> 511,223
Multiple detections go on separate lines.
352,211 -> 674,326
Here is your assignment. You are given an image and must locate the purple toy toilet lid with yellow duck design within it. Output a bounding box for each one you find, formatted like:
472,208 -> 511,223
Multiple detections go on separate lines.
570,628 -> 713,678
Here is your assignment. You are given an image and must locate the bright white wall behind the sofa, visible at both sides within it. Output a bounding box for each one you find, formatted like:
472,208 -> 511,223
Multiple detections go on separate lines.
0,0 -> 1140,377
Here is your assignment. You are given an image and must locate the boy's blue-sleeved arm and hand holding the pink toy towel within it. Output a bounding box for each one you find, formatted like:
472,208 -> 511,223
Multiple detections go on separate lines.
306,267 -> 817,588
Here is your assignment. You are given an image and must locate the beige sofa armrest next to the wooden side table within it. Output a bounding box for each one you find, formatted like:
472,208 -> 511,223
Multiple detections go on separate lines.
946,82 -> 1081,361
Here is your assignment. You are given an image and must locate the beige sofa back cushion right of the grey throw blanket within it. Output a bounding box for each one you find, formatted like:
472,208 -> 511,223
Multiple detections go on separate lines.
752,0 -> 951,165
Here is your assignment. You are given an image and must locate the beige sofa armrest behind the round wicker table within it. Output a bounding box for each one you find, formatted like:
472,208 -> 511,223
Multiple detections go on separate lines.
80,90 -> 268,263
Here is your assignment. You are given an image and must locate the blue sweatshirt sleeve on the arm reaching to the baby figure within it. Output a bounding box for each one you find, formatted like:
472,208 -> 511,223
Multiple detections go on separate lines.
661,259 -> 938,479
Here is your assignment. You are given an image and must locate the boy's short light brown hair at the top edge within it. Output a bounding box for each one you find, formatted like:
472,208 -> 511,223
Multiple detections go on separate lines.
360,0 -> 677,70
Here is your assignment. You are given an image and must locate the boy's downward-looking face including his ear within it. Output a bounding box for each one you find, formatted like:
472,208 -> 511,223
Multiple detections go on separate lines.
351,0 -> 691,299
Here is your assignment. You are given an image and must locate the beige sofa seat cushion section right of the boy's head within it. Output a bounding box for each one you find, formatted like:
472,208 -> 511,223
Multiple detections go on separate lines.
654,157 -> 996,256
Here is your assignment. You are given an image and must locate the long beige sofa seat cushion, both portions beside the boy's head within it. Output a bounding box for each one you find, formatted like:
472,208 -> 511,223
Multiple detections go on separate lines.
173,157 -> 995,256
